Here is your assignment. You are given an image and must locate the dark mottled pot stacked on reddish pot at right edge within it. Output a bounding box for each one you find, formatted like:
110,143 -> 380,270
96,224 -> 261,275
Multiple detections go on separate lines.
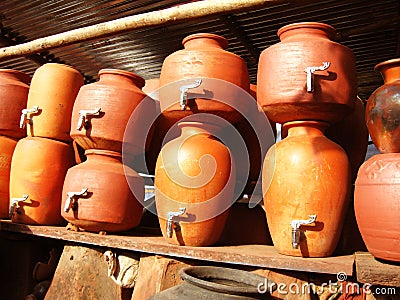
354,59 -> 400,262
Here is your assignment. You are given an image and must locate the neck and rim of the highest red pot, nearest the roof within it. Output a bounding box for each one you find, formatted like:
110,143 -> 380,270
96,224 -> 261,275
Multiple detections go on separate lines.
278,22 -> 336,41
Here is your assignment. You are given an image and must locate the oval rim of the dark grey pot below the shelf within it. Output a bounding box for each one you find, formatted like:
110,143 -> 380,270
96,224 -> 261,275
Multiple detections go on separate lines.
179,266 -> 276,295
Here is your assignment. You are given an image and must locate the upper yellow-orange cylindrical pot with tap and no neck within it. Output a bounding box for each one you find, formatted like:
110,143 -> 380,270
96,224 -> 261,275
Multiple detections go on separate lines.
20,63 -> 83,142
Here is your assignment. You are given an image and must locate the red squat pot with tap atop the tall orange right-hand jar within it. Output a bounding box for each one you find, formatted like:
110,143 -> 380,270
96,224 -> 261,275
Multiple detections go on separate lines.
257,22 -> 357,123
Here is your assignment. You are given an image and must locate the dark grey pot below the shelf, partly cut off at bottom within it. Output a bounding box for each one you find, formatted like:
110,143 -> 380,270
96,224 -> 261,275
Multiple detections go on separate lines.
149,266 -> 276,300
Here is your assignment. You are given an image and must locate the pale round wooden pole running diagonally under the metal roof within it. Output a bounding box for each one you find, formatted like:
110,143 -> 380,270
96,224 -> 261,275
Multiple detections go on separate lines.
0,0 -> 294,59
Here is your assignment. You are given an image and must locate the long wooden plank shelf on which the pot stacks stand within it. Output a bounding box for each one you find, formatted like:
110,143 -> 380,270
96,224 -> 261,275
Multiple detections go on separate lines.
0,220 -> 354,276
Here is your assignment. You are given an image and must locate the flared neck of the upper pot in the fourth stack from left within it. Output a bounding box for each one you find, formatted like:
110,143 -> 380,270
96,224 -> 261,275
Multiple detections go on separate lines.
182,33 -> 228,50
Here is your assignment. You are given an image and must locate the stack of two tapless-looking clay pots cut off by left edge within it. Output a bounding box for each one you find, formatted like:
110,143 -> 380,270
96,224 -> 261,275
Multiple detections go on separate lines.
0,69 -> 31,219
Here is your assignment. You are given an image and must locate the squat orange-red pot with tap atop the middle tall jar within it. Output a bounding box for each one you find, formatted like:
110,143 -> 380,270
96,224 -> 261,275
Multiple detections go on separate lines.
159,33 -> 250,123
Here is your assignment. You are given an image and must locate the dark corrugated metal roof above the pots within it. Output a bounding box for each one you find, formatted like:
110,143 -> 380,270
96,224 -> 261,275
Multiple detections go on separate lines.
0,0 -> 400,99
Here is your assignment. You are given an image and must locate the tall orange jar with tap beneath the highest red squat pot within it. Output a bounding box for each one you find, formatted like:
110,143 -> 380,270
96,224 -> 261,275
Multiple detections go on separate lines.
263,121 -> 350,257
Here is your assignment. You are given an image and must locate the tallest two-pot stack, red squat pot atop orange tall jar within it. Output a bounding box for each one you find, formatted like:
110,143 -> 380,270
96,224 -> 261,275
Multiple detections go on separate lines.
257,22 -> 365,257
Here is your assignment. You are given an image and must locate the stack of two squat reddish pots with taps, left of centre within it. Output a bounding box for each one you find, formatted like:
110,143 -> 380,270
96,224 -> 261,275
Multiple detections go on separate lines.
62,69 -> 155,232
